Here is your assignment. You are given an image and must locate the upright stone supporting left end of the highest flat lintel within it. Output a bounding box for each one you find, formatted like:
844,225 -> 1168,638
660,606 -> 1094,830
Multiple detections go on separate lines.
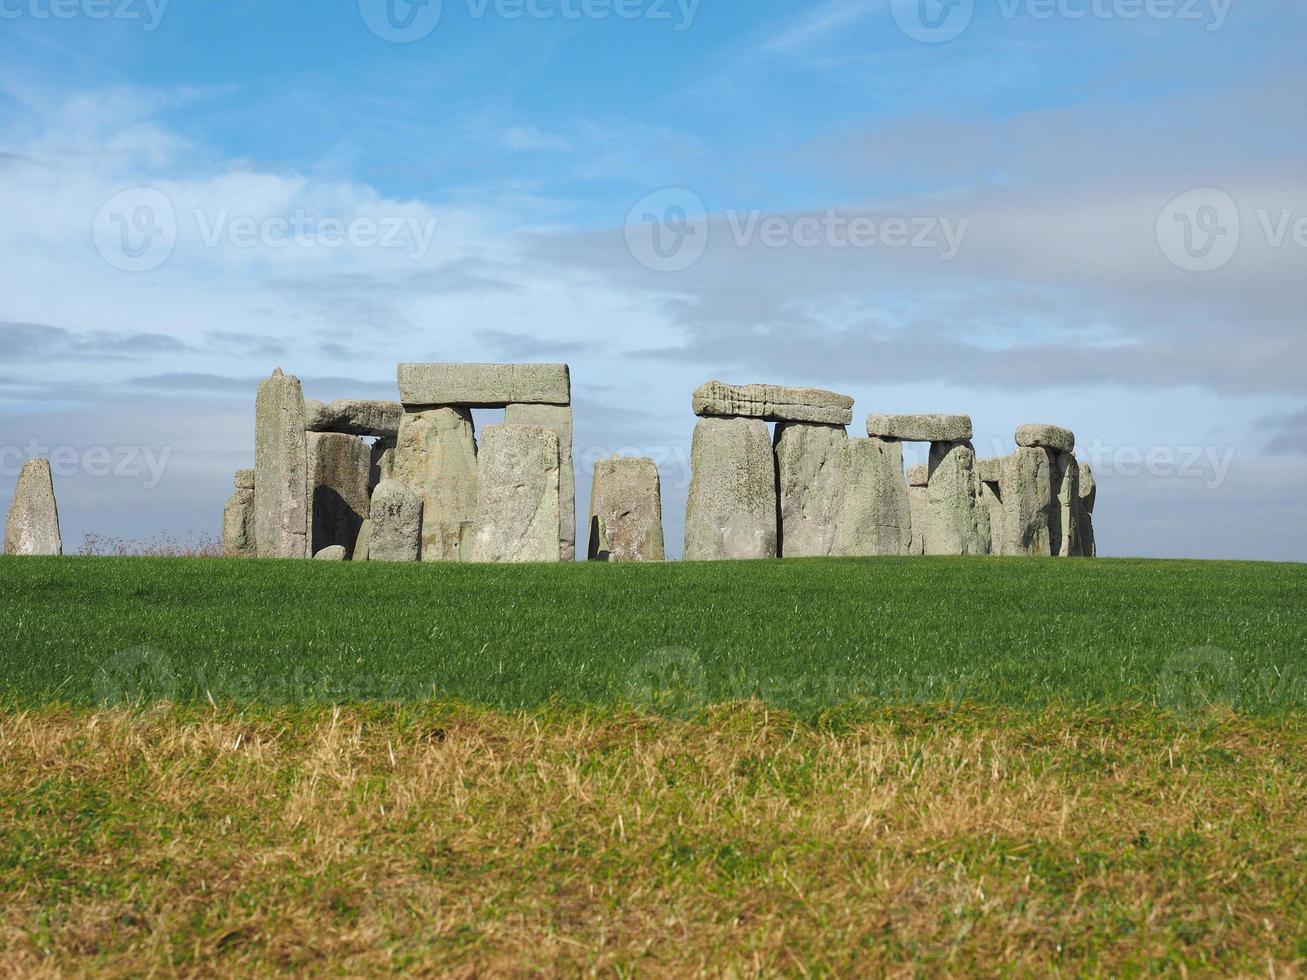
395,408 -> 477,562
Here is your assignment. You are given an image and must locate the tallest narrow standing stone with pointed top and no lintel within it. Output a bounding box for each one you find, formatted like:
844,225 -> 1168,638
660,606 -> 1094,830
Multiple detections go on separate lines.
254,367 -> 308,558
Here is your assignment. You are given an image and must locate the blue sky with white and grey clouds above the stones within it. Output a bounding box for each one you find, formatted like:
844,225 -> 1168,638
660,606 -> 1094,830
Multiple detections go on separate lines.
0,0 -> 1307,561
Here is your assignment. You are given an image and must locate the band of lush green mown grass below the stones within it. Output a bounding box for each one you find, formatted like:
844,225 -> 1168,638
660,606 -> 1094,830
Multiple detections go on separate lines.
0,558 -> 1307,717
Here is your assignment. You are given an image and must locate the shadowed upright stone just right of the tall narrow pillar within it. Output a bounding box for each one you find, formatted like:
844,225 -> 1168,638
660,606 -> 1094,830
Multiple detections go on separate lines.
305,433 -> 372,557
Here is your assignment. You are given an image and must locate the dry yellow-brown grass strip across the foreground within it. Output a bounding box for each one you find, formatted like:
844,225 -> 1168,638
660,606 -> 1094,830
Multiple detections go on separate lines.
0,706 -> 1307,976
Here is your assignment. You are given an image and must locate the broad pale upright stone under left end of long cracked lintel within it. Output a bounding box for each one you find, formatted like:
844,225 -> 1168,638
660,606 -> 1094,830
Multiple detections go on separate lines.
685,418 -> 776,562
